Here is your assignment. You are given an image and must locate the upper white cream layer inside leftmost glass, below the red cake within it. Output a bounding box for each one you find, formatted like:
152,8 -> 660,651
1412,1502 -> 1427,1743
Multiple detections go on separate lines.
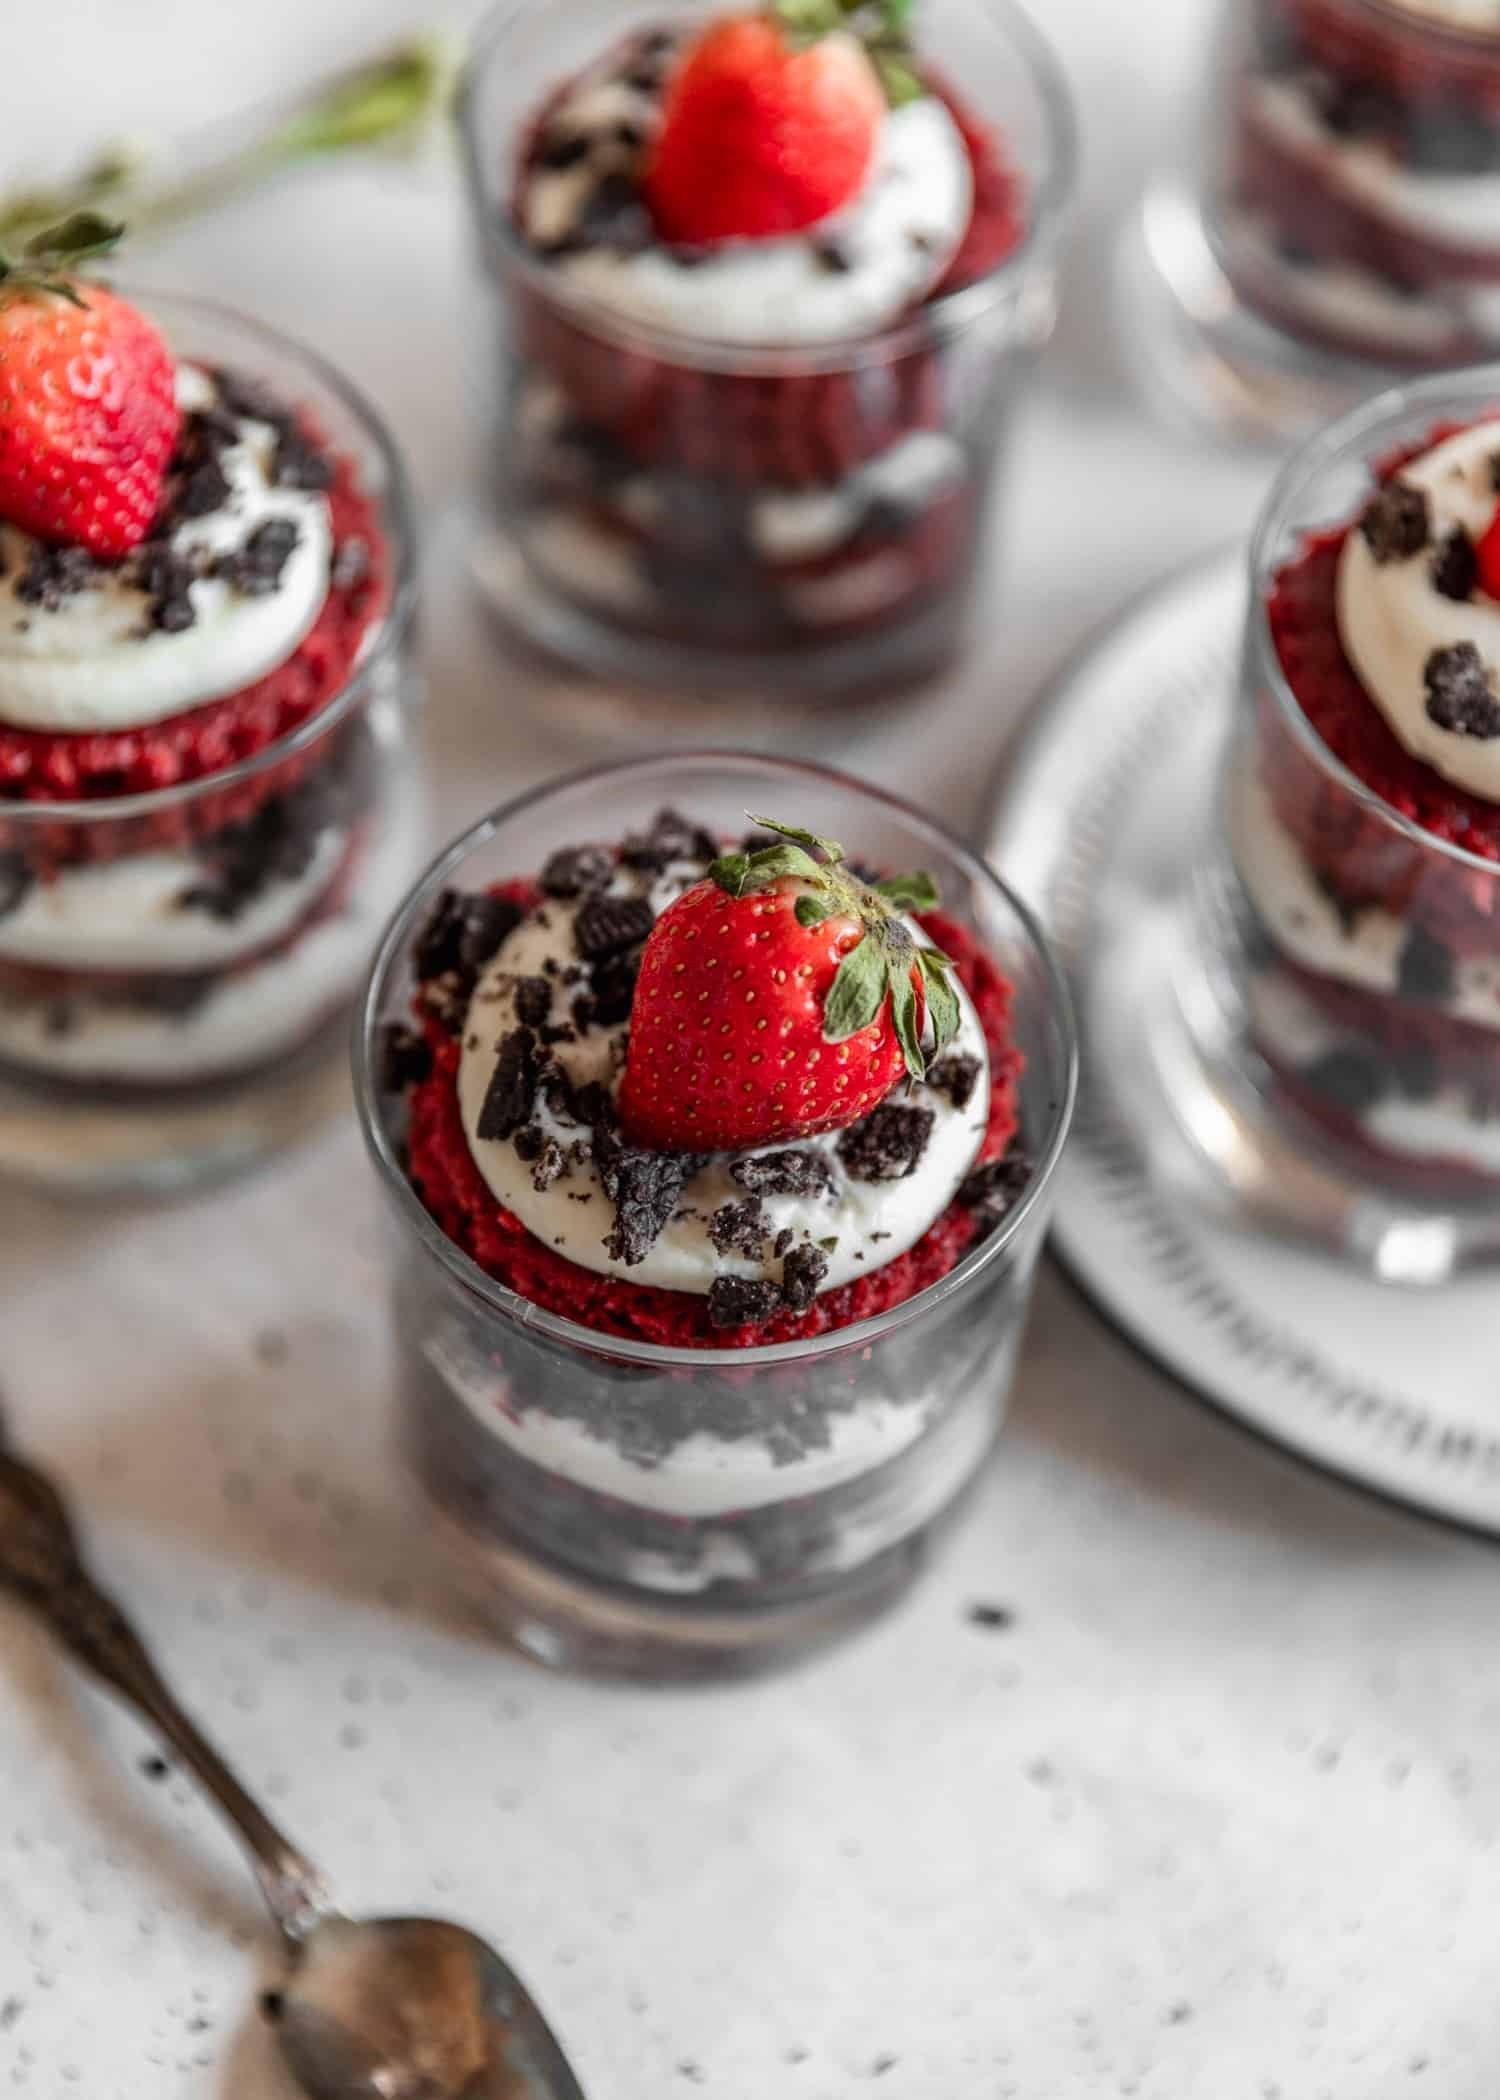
0,825 -> 349,972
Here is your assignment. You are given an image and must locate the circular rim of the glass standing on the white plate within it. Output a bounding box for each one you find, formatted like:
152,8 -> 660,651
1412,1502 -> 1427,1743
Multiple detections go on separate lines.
1248,361 -> 1500,882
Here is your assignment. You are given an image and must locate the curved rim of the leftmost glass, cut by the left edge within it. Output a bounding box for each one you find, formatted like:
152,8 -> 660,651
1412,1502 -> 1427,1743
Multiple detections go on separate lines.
0,279 -> 416,827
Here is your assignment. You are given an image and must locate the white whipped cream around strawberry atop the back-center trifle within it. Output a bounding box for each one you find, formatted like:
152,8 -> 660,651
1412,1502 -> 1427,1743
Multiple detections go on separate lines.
519,46 -> 973,344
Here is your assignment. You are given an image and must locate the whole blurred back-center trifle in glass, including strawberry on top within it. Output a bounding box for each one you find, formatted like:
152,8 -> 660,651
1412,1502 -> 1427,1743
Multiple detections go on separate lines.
455,0 -> 1067,695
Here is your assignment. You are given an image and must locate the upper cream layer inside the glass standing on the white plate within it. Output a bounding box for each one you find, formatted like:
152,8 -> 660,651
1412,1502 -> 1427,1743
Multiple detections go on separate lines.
1229,777 -> 1500,1029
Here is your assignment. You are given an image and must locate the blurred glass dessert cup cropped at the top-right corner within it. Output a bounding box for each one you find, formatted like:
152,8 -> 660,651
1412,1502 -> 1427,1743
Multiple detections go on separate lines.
1122,0 -> 1500,439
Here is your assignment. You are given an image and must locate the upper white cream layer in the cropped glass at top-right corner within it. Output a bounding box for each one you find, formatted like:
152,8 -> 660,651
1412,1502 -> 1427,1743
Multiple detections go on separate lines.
1246,76 -> 1500,254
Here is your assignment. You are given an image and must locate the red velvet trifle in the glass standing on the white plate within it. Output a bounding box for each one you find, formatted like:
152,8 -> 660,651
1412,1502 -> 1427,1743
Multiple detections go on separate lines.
1227,368 -> 1500,1212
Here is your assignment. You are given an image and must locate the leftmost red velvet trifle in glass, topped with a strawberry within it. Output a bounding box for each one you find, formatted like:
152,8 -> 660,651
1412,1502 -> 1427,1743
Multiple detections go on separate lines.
0,229 -> 416,1187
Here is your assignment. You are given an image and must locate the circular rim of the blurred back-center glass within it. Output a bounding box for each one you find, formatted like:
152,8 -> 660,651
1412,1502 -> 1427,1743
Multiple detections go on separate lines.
456,0 -> 1078,376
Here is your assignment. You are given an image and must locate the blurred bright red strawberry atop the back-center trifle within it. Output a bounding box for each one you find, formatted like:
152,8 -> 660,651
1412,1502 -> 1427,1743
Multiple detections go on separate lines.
645,15 -> 887,246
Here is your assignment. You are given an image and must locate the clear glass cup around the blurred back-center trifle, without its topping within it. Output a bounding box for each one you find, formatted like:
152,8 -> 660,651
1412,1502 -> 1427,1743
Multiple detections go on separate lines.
462,0 -> 1071,725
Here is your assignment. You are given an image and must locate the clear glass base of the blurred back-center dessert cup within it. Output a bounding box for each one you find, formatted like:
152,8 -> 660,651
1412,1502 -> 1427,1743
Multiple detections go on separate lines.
466,517 -> 966,726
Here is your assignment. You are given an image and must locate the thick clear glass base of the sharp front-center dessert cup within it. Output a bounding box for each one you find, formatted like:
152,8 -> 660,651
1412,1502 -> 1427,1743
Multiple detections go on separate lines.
422,1493 -> 966,1684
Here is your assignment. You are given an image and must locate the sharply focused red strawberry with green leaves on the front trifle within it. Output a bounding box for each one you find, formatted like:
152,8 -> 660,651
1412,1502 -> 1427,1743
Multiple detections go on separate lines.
620,817 -> 958,1153
